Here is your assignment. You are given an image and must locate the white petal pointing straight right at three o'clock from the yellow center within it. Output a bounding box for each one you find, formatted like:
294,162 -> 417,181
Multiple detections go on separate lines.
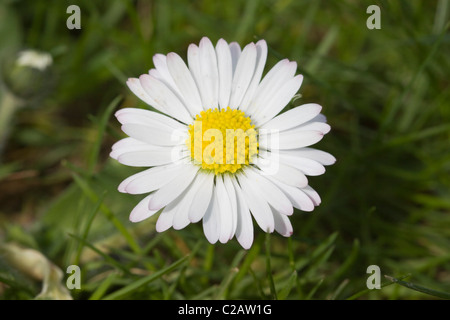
258,130 -> 323,150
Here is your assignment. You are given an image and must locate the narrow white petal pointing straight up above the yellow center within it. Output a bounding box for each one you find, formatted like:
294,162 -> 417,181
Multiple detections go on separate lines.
216,39 -> 233,109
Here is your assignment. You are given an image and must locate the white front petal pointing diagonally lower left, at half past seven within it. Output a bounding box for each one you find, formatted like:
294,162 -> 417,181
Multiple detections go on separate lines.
149,165 -> 199,210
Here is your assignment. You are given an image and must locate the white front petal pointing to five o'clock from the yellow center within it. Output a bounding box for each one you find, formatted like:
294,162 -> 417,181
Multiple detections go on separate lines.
238,174 -> 274,233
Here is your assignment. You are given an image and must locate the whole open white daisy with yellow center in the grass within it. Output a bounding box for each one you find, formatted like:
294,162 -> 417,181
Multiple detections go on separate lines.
111,38 -> 335,249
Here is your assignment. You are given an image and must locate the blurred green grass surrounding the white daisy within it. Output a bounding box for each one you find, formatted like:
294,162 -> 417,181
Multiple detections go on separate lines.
0,0 -> 450,299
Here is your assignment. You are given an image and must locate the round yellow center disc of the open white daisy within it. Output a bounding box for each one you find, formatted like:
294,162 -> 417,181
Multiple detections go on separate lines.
186,107 -> 258,175
